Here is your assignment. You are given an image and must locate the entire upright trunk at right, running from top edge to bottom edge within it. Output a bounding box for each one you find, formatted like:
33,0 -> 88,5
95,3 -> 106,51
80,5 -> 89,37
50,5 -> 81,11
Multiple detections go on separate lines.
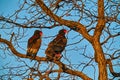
92,0 -> 108,80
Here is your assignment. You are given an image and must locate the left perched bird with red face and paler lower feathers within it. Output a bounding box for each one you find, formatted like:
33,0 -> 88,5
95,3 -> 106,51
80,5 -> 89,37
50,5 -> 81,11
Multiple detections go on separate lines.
26,30 -> 42,60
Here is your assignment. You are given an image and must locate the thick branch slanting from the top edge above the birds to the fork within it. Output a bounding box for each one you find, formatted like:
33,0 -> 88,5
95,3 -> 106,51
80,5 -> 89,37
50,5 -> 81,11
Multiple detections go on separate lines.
36,0 -> 92,42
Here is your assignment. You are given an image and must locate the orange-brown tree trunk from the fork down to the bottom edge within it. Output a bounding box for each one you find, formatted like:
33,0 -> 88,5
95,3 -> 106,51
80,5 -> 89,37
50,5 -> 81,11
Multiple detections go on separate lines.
93,38 -> 108,80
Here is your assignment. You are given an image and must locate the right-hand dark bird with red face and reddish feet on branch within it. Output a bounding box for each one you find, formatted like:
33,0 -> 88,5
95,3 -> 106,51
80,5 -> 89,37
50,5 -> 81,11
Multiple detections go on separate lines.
45,29 -> 67,61
